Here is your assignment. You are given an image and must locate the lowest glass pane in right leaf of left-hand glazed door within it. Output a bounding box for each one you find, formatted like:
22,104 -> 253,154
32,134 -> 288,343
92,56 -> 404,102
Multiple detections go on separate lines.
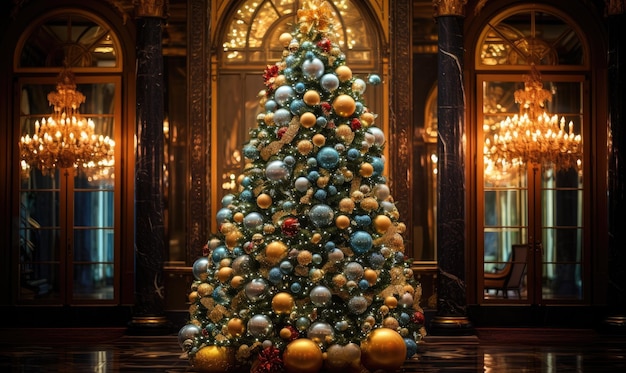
73,263 -> 114,300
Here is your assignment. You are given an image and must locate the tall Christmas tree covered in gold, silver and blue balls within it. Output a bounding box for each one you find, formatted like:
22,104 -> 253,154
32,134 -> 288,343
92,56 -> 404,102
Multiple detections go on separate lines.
178,0 -> 425,373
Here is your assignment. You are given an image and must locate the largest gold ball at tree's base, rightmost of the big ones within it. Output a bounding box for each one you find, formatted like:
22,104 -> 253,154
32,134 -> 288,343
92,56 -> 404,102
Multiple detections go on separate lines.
361,328 -> 406,372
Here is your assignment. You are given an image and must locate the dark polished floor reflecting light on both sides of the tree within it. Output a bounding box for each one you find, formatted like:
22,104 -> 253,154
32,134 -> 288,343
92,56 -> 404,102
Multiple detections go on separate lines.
0,329 -> 626,373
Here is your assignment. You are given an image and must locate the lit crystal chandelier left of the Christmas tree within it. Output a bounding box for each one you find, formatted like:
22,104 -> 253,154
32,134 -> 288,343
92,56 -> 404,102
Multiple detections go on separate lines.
19,68 -> 115,175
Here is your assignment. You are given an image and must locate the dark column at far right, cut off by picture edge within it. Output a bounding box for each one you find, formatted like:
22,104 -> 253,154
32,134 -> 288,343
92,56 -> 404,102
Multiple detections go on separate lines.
606,0 -> 626,333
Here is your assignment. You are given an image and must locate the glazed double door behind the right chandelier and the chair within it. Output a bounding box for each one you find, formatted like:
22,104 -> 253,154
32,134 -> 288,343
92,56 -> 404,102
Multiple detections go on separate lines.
477,76 -> 586,304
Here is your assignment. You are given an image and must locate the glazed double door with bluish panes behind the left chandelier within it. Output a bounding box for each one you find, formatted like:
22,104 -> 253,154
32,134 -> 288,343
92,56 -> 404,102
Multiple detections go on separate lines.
17,78 -> 120,304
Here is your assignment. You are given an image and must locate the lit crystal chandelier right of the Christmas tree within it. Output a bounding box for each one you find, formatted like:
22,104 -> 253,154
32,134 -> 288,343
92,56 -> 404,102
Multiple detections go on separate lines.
483,64 -> 582,174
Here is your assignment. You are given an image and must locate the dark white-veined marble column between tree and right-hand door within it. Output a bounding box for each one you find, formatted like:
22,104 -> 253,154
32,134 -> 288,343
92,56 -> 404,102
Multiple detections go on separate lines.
429,0 -> 474,335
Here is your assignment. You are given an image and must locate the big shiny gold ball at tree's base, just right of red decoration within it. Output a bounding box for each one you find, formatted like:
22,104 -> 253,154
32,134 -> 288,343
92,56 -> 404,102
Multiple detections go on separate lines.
283,338 -> 322,373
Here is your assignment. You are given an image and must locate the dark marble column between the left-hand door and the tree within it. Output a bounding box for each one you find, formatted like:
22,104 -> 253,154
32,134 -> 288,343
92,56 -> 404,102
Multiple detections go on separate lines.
130,0 -> 168,334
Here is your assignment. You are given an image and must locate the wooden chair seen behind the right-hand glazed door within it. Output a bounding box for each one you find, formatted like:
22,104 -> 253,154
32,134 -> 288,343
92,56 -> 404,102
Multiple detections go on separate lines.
485,244 -> 528,298
